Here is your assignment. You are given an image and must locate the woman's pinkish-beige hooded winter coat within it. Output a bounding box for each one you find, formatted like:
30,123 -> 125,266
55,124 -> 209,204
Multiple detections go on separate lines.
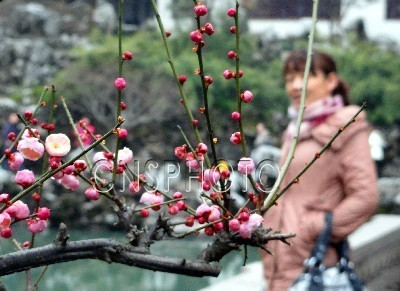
262,106 -> 378,291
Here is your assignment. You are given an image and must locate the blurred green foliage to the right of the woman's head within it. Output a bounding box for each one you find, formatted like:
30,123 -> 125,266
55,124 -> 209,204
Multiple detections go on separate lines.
333,43 -> 400,126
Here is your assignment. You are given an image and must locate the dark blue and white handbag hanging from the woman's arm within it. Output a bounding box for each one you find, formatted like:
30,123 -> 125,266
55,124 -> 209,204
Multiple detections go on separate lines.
289,212 -> 366,291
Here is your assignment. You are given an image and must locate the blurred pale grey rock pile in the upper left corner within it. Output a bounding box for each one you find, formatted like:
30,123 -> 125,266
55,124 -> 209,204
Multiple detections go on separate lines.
0,1 -> 91,95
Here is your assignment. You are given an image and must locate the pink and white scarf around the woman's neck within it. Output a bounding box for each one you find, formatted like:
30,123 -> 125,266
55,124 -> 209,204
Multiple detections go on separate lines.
285,95 -> 344,141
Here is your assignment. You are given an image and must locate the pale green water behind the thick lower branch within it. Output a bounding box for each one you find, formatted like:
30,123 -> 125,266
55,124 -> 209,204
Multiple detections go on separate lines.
0,231 -> 258,291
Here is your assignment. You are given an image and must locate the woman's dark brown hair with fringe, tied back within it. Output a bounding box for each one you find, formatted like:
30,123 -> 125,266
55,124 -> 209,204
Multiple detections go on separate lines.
283,51 -> 350,105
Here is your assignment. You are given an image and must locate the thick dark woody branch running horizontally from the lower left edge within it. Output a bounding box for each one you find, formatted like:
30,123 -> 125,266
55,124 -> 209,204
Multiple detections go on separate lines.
0,238 -> 221,277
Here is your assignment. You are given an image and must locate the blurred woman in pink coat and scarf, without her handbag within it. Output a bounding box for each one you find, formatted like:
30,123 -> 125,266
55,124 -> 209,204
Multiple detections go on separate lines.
262,51 -> 378,291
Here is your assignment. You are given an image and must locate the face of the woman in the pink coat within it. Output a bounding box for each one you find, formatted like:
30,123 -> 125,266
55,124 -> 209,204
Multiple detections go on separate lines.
285,70 -> 338,108
